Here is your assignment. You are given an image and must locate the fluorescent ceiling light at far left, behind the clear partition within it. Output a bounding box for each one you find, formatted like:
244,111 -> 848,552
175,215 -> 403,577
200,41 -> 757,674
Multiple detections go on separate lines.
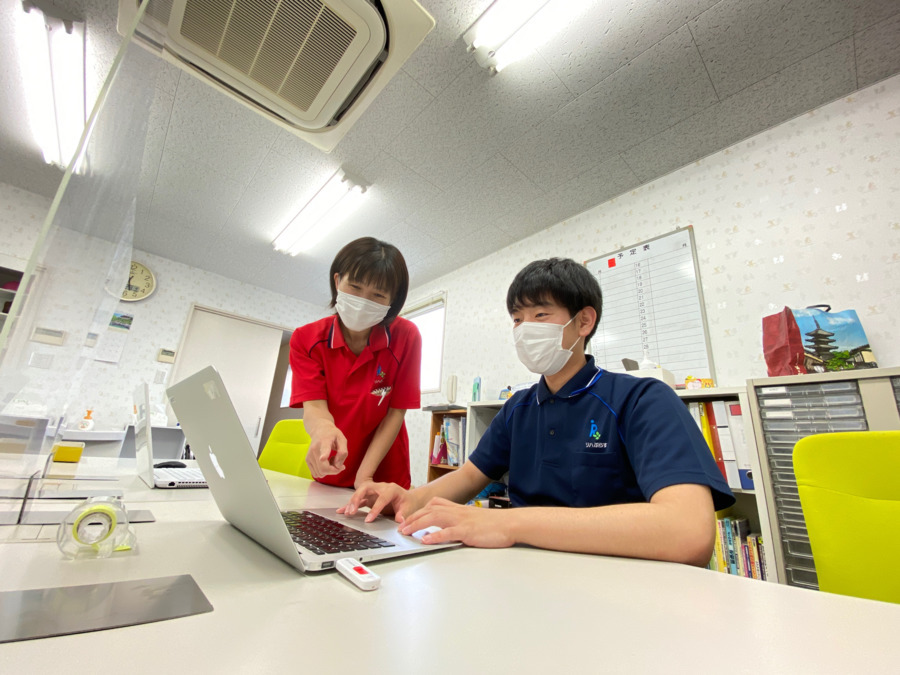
16,0 -> 85,168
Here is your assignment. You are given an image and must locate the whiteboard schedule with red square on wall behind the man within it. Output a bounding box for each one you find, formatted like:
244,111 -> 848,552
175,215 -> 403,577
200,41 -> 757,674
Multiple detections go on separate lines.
584,226 -> 715,383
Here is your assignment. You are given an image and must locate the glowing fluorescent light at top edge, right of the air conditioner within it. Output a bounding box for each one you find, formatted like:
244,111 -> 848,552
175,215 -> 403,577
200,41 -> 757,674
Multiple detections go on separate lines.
463,0 -> 593,73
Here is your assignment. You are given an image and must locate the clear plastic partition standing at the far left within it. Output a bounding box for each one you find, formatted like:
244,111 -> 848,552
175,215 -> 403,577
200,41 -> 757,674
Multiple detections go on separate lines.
0,2 -> 161,476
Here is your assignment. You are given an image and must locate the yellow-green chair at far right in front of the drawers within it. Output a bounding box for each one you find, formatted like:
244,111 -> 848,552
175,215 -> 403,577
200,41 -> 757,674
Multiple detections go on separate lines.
794,431 -> 900,603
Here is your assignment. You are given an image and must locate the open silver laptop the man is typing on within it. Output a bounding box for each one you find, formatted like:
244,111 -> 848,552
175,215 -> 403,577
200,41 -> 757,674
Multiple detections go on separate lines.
167,366 -> 459,572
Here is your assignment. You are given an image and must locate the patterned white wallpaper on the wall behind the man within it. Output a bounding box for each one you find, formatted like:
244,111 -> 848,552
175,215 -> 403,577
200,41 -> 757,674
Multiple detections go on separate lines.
407,76 -> 900,483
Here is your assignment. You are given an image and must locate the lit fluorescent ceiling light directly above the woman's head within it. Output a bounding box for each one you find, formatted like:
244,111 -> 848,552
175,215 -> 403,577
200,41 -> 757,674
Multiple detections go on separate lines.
272,169 -> 367,255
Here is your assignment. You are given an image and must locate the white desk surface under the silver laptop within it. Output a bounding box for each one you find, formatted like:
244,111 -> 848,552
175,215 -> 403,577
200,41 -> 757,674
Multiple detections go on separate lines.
0,473 -> 900,675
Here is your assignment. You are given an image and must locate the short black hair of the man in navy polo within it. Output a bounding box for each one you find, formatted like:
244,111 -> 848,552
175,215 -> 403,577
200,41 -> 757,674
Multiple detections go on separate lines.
506,258 -> 603,343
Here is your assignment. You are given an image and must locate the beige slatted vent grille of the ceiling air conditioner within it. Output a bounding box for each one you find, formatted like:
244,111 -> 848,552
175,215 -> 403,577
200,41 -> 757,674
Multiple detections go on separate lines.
181,0 -> 356,111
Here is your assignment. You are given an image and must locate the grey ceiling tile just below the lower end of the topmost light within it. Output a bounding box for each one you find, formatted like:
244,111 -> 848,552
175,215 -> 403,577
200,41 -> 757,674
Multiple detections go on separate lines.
388,55 -> 572,189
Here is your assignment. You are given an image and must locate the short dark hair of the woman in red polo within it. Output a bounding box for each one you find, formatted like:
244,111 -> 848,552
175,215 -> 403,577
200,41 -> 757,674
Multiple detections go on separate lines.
328,237 -> 409,326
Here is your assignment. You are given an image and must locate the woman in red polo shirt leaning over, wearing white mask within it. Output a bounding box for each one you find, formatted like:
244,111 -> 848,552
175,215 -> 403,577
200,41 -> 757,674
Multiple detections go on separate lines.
291,237 -> 422,488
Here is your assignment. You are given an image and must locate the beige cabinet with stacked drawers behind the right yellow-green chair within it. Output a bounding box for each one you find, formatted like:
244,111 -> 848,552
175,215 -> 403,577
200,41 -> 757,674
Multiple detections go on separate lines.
747,368 -> 900,589
